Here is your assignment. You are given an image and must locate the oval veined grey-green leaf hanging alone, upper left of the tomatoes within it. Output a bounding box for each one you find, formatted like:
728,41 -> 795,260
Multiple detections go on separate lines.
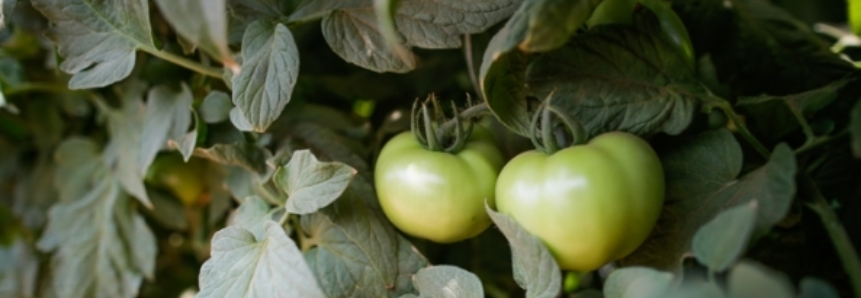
232,20 -> 299,132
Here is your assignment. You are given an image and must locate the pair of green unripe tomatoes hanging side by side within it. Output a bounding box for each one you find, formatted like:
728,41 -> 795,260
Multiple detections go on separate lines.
375,116 -> 664,272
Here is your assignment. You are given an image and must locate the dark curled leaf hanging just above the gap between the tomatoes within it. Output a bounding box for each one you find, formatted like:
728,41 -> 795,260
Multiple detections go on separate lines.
479,27 -> 531,136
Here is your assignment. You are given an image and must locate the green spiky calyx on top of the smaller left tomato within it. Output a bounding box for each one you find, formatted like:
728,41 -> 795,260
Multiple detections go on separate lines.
410,94 -> 487,153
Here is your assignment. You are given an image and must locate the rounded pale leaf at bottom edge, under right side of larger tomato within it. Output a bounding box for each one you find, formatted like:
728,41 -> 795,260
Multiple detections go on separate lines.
604,267 -> 673,298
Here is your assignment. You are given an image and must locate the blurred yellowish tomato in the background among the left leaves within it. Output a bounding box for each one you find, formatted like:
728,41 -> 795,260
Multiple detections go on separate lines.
144,153 -> 206,206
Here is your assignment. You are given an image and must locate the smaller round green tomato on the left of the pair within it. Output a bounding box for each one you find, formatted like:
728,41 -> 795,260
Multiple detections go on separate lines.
374,126 -> 503,243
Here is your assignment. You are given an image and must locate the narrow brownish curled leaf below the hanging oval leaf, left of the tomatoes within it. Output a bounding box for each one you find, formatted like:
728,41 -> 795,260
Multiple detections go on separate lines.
194,142 -> 272,177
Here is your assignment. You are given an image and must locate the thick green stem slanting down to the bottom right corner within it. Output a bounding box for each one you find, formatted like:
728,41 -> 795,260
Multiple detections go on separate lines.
799,174 -> 861,298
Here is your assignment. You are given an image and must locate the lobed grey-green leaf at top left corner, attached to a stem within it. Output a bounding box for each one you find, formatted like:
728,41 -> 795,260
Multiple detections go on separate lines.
32,0 -> 157,89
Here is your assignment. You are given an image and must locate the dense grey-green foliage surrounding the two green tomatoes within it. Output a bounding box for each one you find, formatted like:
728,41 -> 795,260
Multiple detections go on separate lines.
0,0 -> 861,298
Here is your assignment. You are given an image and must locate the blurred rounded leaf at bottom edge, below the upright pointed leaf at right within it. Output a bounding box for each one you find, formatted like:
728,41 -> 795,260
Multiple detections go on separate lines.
727,262 -> 795,298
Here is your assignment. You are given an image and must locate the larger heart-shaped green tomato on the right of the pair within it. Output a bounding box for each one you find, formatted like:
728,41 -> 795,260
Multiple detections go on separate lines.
496,132 -> 664,272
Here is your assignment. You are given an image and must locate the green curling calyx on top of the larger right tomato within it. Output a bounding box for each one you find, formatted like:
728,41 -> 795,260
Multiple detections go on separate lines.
529,92 -> 588,155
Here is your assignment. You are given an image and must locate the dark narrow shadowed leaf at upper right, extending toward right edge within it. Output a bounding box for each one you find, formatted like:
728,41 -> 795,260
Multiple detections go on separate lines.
737,80 -> 852,140
